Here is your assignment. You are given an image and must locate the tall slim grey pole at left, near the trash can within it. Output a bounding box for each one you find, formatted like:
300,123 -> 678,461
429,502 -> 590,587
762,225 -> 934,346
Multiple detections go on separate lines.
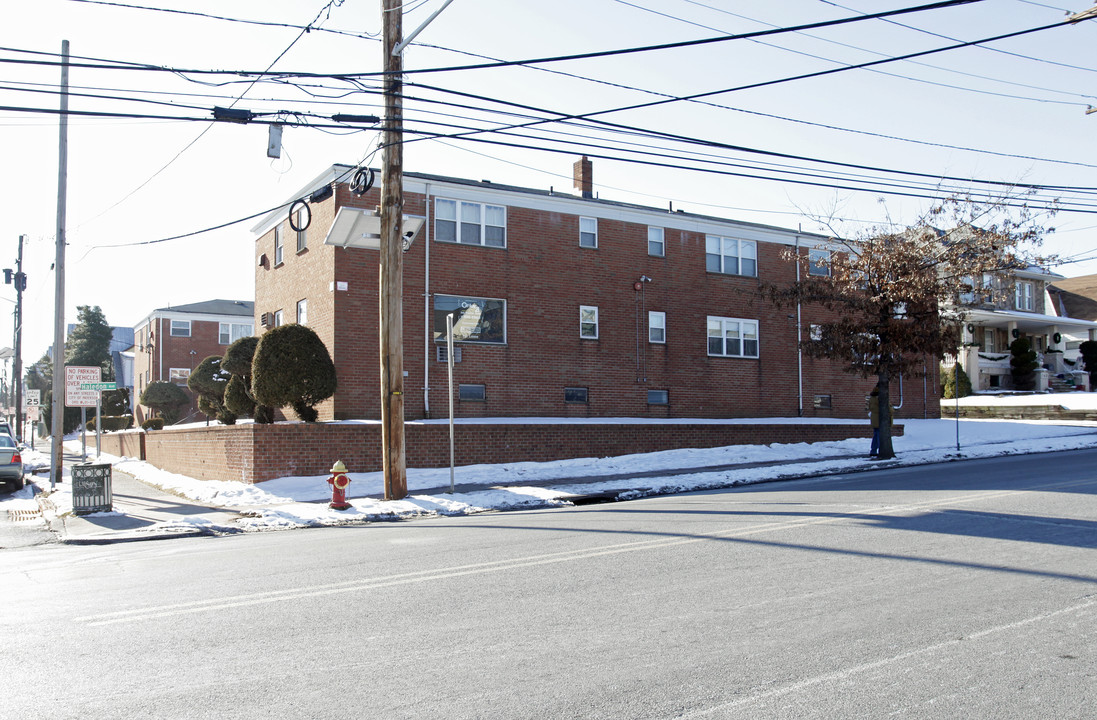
49,40 -> 69,490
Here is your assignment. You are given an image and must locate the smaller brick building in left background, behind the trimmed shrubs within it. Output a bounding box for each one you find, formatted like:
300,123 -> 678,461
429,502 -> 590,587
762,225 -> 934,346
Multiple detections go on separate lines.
133,300 -> 255,423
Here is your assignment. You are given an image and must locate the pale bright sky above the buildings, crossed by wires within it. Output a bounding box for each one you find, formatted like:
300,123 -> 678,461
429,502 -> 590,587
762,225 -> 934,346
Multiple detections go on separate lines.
0,0 -> 1097,362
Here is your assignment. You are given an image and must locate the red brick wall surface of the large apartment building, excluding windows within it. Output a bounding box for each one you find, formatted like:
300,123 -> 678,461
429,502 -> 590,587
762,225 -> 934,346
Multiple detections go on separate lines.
256,175 -> 940,419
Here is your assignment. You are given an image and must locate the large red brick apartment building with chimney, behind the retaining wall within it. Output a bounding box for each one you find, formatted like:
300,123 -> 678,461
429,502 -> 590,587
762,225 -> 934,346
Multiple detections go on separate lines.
251,158 -> 940,419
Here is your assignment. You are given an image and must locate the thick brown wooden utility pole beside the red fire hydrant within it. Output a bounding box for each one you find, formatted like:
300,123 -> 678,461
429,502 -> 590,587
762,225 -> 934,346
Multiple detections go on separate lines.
380,0 -> 408,500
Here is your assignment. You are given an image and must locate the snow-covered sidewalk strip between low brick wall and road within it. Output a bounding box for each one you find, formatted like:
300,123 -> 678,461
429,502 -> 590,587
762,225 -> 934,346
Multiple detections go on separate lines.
17,420 -> 1097,544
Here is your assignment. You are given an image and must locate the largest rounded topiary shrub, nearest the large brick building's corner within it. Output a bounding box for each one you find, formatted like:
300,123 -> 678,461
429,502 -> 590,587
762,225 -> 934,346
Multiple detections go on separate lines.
251,323 -> 336,423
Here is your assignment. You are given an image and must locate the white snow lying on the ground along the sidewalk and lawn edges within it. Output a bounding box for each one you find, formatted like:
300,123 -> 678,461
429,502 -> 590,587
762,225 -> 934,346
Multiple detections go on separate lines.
0,393 -> 1097,530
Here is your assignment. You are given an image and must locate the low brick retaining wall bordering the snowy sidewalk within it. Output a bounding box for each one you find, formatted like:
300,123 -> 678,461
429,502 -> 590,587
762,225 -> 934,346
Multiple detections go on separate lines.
96,421 -> 904,483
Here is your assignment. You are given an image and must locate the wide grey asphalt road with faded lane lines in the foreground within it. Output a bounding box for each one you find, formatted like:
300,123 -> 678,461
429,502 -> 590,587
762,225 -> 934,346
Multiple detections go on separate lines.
0,451 -> 1097,720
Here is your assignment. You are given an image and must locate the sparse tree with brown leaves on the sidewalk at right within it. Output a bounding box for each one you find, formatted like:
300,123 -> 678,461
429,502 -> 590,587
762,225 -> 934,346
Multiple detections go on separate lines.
761,199 -> 1048,459
